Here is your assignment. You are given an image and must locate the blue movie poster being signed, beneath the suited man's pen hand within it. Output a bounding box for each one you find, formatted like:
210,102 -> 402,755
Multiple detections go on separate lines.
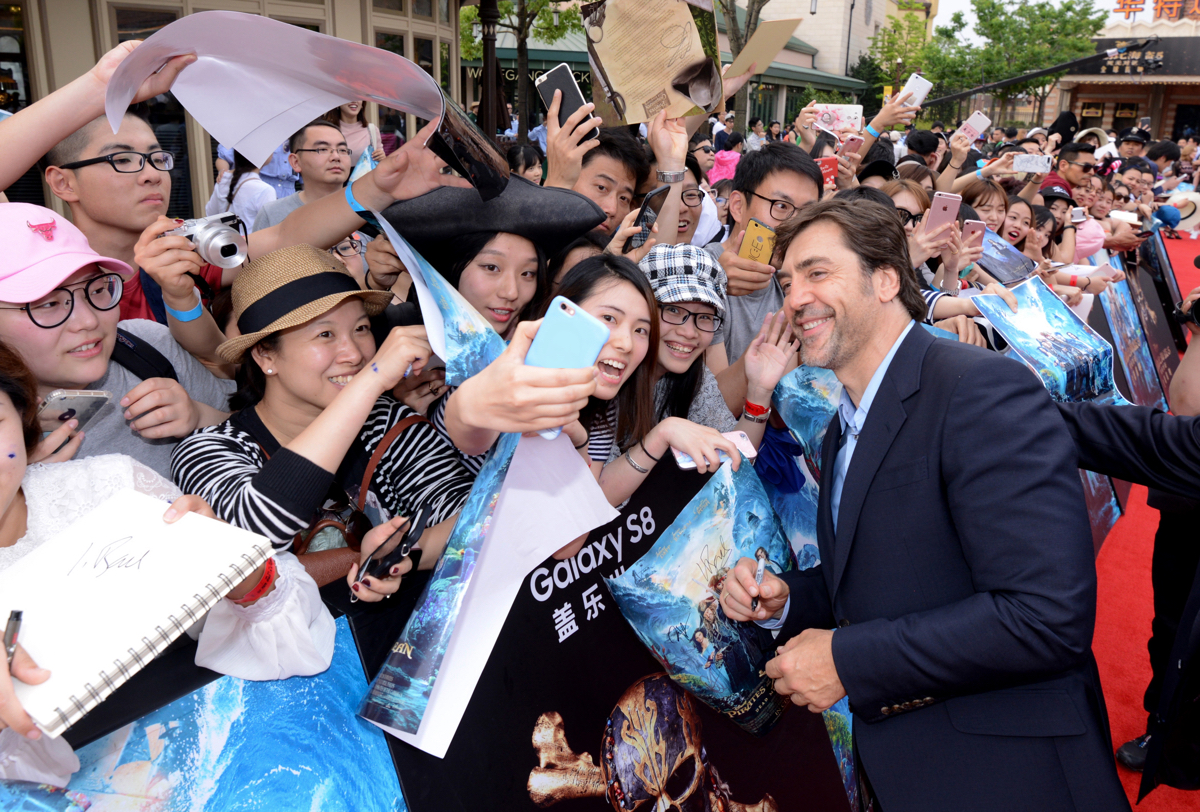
607,459 -> 796,734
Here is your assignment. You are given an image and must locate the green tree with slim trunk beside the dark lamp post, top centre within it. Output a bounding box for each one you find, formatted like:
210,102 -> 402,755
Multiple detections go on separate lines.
458,0 -> 583,143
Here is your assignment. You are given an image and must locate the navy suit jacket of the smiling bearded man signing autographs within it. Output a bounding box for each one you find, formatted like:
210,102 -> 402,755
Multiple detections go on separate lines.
780,330 -> 1129,812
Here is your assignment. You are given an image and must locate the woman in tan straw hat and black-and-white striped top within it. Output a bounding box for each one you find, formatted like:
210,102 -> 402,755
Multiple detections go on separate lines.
172,246 -> 472,590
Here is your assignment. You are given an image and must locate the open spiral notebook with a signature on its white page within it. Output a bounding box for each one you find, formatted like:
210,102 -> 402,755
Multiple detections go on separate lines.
0,491 -> 271,736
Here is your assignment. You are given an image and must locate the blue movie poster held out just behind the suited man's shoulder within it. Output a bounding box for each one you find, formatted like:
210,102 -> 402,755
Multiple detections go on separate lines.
972,277 -> 1126,404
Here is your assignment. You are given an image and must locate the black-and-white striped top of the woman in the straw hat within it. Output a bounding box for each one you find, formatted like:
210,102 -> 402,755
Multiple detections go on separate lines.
170,395 -> 474,549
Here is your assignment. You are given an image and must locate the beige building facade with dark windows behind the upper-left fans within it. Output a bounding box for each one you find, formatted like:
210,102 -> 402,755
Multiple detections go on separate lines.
0,0 -> 460,217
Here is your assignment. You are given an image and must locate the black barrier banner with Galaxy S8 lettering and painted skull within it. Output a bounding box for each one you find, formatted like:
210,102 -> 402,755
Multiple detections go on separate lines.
388,461 -> 848,812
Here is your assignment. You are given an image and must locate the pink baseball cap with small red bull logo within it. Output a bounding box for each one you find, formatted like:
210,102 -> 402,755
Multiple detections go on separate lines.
0,203 -> 133,303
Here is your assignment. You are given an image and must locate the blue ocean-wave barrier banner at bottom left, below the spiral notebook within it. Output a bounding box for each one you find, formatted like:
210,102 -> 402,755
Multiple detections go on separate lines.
68,618 -> 406,812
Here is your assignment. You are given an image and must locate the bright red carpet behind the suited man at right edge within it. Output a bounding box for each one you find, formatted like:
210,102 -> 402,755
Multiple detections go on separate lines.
1092,232 -> 1200,812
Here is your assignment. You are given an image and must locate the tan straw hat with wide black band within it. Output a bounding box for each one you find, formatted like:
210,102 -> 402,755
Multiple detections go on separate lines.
217,245 -> 391,363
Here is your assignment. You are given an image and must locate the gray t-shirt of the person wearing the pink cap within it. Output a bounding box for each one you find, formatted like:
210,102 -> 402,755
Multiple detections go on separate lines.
76,319 -> 238,480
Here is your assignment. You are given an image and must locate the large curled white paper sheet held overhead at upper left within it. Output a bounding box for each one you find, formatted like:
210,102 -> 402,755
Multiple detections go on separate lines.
104,11 -> 445,166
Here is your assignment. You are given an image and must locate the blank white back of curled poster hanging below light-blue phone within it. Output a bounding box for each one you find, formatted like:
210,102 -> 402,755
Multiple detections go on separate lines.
394,434 -> 617,758
